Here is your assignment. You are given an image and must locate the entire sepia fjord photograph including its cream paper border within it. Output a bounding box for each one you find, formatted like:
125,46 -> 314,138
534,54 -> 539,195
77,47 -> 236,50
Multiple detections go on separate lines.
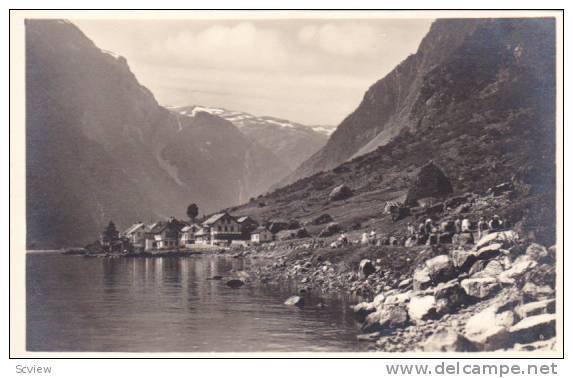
10,10 -> 563,358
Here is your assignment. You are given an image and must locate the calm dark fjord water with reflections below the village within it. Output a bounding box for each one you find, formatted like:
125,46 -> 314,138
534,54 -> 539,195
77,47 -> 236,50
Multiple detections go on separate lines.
26,253 -> 365,352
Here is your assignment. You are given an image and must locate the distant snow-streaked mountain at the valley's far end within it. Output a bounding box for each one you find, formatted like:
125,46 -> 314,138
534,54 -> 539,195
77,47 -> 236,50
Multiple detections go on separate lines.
170,106 -> 328,171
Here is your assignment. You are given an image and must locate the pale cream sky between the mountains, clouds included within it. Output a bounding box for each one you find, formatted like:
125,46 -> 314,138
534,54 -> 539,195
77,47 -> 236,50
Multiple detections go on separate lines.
71,19 -> 433,126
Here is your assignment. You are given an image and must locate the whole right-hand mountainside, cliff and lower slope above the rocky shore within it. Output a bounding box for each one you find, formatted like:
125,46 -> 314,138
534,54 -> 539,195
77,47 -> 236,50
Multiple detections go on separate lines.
227,19 -> 556,245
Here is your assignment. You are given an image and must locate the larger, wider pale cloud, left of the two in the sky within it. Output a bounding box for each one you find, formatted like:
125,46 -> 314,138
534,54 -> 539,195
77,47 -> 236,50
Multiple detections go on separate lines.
149,22 -> 309,70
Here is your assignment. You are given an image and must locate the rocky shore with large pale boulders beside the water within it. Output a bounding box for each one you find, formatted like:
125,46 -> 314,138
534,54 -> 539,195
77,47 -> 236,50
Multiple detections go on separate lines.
230,230 -> 556,352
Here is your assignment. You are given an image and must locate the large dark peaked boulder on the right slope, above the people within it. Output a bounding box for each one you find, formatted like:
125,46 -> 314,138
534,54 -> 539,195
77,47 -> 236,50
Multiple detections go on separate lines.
405,162 -> 453,206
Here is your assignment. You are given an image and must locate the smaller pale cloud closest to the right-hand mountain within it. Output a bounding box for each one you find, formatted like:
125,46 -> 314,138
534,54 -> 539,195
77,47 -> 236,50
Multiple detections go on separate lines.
298,23 -> 386,57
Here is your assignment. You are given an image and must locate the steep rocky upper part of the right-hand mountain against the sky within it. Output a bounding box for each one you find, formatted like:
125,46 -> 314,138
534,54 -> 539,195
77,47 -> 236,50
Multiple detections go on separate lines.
283,19 -> 554,184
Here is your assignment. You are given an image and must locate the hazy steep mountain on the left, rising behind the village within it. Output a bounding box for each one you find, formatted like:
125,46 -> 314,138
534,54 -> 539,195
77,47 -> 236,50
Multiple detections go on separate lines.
26,20 -> 289,248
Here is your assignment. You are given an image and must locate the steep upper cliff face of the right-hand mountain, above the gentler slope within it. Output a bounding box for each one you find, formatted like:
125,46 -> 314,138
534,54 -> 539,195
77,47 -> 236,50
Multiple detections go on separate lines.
283,19 -> 552,187
